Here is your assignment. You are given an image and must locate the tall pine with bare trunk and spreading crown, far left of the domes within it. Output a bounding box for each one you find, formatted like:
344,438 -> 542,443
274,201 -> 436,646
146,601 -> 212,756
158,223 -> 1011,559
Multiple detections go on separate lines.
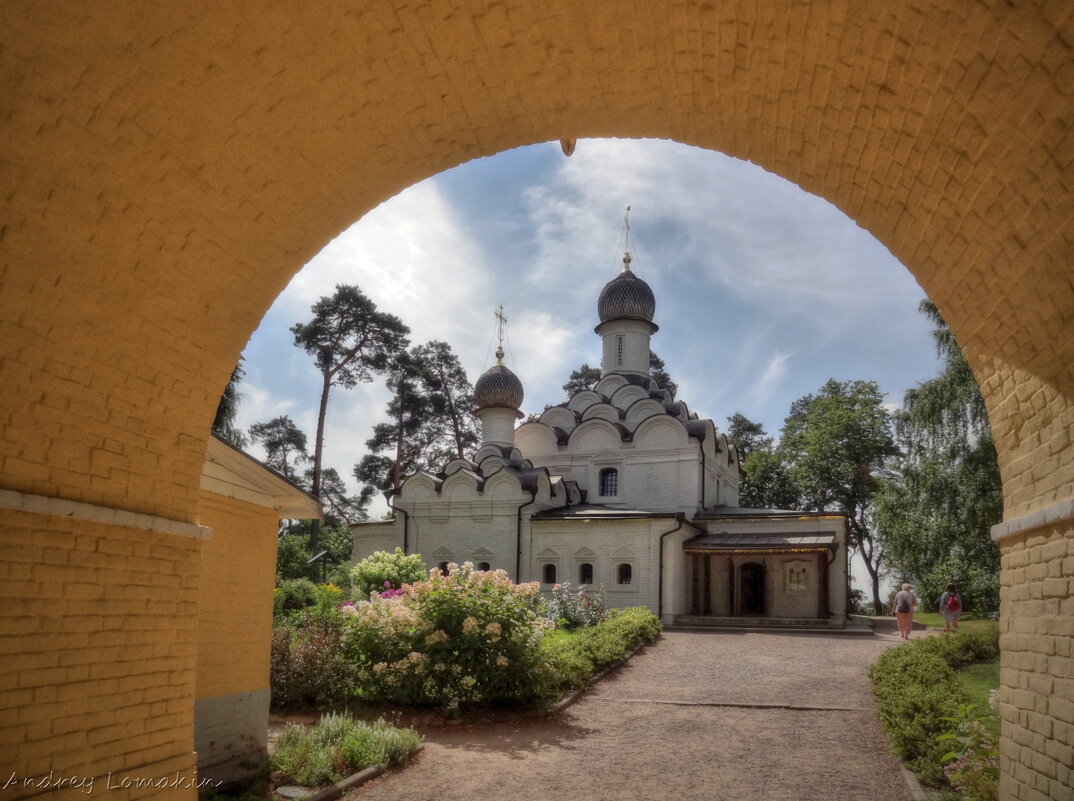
291,285 -> 410,551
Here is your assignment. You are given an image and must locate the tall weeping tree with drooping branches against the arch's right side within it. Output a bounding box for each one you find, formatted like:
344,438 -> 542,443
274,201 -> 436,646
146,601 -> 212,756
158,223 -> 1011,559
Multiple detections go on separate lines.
876,301 -> 1003,612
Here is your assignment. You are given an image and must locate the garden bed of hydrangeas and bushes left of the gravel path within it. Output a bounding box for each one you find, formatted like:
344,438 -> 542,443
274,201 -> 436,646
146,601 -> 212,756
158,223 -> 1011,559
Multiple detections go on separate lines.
272,565 -> 661,719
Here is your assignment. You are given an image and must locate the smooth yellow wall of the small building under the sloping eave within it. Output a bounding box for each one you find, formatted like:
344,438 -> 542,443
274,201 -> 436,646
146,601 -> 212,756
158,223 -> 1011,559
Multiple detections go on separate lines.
197,492 -> 277,698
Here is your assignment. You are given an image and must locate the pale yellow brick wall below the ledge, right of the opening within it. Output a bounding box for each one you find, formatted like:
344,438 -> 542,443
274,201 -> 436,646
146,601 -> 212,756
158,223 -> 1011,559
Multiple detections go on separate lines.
1000,521 -> 1074,801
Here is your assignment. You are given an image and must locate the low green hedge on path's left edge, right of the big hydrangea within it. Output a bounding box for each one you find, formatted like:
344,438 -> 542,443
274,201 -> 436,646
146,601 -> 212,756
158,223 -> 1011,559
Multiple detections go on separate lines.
541,607 -> 662,689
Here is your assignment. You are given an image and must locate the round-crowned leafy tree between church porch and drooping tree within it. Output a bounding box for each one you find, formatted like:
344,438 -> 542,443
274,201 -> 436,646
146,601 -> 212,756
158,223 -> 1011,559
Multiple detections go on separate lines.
780,379 -> 898,614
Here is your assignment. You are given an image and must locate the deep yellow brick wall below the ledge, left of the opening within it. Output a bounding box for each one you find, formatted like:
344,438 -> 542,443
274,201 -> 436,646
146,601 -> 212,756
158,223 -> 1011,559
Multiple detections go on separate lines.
0,511 -> 201,799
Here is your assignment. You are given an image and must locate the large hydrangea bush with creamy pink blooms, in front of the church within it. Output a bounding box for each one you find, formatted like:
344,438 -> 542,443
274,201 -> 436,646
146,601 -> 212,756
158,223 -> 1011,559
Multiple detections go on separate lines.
343,563 -> 554,705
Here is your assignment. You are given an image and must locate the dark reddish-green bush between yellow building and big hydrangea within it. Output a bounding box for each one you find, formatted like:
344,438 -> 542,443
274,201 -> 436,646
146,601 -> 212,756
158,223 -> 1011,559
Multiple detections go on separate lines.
270,612 -> 353,710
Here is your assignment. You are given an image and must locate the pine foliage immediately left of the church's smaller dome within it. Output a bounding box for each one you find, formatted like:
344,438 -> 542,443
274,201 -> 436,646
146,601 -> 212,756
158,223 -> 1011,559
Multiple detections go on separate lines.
413,340 -> 480,465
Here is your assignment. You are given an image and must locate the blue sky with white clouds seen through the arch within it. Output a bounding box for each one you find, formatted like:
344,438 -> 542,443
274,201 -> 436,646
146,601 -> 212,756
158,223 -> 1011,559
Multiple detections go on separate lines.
238,140 -> 938,588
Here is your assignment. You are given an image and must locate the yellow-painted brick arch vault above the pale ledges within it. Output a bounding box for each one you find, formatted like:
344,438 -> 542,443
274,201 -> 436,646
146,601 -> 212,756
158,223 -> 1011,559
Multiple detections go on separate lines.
0,0 -> 1074,794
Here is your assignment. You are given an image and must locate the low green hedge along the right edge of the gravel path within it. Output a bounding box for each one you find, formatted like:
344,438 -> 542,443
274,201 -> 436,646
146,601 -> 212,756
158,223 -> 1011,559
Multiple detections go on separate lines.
869,626 -> 999,784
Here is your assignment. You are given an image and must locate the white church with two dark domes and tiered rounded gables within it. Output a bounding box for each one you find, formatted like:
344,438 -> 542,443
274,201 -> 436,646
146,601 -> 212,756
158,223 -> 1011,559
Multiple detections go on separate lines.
351,253 -> 847,627
